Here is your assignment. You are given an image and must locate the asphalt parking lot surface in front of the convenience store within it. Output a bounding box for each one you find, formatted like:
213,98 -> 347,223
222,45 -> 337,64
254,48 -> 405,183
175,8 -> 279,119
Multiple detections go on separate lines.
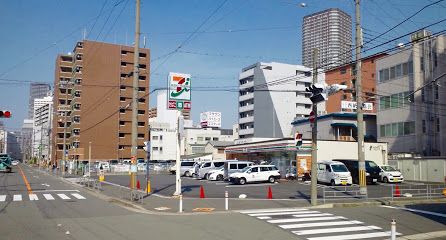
102,172 -> 446,201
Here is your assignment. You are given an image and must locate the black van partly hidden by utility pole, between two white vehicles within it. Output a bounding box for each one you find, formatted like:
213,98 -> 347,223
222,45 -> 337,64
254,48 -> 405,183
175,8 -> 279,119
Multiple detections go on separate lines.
333,159 -> 381,184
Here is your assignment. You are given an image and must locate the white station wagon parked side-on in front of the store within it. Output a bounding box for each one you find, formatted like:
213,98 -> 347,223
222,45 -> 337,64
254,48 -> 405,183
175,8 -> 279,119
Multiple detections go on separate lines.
229,165 -> 280,185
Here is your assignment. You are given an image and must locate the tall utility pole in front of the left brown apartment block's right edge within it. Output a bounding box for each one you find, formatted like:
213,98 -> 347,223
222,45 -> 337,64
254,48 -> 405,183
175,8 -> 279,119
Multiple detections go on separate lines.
130,0 -> 140,189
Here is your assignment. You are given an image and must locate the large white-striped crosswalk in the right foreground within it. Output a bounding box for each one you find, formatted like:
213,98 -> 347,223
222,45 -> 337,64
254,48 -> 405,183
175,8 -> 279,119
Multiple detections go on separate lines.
239,208 -> 401,240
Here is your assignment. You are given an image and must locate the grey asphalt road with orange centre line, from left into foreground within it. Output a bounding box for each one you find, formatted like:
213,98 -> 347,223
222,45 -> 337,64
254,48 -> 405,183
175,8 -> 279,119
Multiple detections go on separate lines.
0,165 -> 295,240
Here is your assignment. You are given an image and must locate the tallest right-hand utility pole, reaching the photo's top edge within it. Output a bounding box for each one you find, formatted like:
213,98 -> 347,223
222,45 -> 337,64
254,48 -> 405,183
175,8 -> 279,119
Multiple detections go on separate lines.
355,0 -> 367,195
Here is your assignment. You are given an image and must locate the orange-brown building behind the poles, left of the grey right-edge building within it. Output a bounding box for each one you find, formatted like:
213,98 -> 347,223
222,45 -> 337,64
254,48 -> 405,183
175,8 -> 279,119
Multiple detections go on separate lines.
325,53 -> 387,113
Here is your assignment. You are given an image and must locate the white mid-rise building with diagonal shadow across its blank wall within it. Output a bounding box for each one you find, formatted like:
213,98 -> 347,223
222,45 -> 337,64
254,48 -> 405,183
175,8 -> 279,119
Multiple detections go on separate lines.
238,62 -> 325,138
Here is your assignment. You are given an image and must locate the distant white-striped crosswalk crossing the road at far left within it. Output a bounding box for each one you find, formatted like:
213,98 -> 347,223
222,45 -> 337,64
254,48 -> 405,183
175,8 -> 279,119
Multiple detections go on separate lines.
0,193 -> 86,203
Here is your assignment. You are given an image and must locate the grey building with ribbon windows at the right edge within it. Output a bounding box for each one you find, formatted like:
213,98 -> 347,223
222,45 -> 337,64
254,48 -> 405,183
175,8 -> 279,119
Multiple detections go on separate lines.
376,30 -> 446,156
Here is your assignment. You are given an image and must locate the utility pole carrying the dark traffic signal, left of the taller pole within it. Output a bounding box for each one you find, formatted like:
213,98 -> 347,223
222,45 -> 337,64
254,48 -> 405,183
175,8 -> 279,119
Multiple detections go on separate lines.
311,48 -> 318,206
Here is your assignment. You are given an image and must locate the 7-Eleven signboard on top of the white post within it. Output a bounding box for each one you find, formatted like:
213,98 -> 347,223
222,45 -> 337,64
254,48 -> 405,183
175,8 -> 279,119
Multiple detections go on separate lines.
167,73 -> 191,110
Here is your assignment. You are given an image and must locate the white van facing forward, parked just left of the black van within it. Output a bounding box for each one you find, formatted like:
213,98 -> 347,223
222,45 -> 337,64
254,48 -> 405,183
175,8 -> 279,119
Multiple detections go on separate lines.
317,161 -> 352,186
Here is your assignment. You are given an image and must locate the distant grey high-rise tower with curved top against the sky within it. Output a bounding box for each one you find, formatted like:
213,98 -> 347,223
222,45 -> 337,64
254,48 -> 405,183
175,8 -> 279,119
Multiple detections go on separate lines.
302,8 -> 352,69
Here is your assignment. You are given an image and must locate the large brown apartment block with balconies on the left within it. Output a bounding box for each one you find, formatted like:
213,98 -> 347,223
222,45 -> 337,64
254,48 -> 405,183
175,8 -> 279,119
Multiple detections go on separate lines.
52,40 -> 150,164
